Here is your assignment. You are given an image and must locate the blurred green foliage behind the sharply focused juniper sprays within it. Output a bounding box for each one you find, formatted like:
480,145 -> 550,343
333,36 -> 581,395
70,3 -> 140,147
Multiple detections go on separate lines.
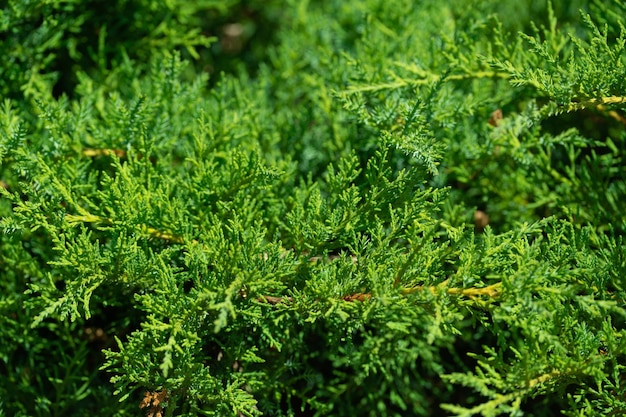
0,0 -> 626,416
